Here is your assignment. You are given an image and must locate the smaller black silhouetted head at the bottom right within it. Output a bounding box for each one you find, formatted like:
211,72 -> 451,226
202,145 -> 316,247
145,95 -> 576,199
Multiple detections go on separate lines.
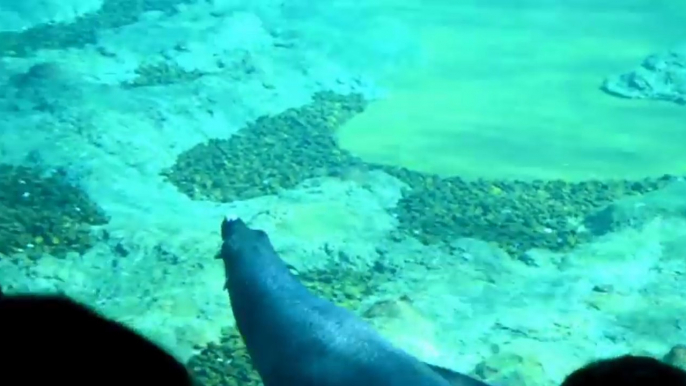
562,355 -> 686,386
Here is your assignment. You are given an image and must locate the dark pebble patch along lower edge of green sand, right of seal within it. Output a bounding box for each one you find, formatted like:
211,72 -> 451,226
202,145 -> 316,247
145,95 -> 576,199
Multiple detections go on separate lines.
397,177 -> 671,255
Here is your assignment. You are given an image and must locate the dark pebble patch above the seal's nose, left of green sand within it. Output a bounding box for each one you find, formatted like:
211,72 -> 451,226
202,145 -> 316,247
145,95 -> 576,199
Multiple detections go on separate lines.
164,92 -> 365,202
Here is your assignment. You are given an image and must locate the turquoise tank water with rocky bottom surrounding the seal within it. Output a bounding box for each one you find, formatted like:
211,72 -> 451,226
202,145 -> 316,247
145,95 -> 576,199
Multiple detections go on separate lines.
0,0 -> 686,386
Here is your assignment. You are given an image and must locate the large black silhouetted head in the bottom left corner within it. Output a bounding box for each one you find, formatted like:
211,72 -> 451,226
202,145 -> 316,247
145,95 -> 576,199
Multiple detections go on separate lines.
0,294 -> 192,386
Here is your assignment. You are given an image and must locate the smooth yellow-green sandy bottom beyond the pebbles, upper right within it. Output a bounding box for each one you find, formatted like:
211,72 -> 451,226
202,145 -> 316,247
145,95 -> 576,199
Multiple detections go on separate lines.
338,0 -> 686,180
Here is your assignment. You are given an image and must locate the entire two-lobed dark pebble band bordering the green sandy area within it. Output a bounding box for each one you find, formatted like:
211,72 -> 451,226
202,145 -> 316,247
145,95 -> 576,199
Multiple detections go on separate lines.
164,92 -> 672,256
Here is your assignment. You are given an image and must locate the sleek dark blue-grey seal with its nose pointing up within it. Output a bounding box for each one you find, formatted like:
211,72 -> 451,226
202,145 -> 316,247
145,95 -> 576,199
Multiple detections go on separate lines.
217,216 -> 488,386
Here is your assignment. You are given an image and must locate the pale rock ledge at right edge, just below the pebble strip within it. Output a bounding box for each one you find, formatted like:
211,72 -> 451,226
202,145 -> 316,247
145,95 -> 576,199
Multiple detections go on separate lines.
584,177 -> 686,235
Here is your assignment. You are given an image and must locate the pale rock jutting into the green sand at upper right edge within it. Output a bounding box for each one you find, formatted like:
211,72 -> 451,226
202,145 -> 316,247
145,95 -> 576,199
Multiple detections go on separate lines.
602,49 -> 686,105
